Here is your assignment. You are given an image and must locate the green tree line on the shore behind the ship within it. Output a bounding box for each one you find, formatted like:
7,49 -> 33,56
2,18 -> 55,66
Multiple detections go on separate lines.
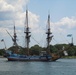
0,44 -> 76,56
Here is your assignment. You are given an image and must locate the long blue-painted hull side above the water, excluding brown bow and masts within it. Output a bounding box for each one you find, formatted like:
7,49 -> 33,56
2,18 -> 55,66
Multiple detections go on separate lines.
7,56 -> 51,61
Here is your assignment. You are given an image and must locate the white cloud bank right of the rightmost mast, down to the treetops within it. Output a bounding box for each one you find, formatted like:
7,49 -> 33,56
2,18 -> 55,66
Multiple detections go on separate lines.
47,17 -> 76,44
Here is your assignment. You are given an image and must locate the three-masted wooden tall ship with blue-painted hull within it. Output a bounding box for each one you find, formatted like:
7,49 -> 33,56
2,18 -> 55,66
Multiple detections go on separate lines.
7,10 -> 72,61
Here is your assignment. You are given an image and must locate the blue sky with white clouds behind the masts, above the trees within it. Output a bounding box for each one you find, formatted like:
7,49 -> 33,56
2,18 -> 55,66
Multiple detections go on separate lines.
0,0 -> 76,49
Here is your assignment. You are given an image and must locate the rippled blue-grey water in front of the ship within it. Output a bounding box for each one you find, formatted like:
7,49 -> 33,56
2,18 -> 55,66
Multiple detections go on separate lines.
0,58 -> 76,75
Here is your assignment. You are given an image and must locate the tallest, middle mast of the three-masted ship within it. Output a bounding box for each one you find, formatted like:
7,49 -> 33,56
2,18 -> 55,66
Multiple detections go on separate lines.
24,10 -> 31,55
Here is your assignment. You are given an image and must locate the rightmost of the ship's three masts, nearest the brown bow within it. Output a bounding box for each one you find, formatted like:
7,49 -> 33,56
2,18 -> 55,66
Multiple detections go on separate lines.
46,15 -> 53,54
